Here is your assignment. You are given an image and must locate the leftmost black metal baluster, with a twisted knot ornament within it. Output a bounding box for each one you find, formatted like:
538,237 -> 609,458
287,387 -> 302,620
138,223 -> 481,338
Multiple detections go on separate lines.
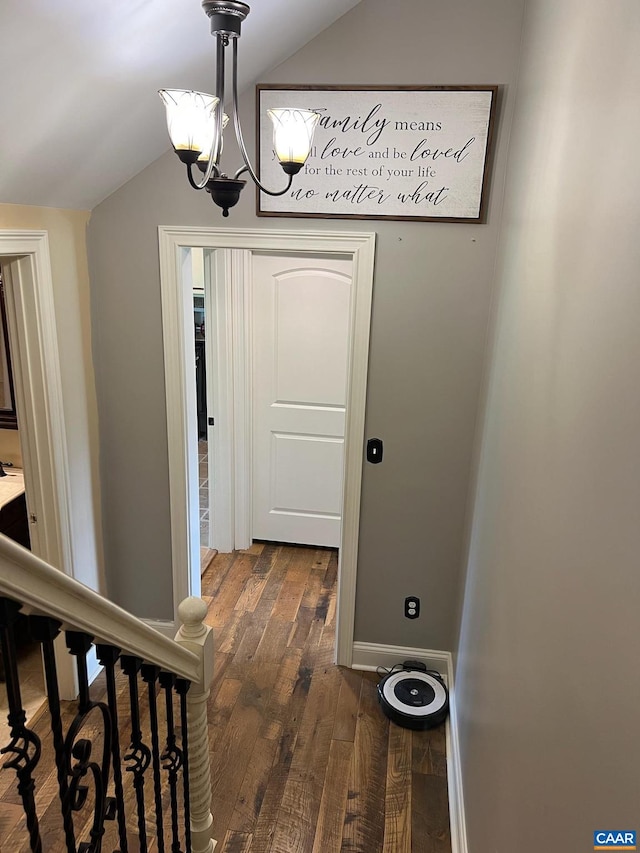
0,598 -> 42,853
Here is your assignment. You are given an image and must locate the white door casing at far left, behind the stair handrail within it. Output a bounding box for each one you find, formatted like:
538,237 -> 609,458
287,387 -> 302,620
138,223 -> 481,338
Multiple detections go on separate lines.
0,230 -> 77,699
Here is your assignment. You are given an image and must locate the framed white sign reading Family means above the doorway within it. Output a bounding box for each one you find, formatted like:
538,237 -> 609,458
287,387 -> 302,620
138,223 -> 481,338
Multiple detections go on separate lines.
256,85 -> 498,222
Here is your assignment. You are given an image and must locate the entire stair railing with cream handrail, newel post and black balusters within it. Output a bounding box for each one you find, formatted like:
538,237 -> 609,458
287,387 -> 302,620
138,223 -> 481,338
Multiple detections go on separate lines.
0,535 -> 215,853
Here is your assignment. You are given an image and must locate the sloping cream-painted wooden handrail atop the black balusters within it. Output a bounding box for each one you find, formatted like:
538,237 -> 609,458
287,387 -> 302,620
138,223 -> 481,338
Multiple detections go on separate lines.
0,534 -> 202,683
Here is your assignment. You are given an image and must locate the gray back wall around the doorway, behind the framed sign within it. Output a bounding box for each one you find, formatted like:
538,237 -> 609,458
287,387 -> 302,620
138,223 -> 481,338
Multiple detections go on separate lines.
89,0 -> 522,648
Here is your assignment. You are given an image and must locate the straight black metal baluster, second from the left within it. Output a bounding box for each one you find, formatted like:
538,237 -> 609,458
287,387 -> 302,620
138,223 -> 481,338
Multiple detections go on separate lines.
29,616 -> 76,853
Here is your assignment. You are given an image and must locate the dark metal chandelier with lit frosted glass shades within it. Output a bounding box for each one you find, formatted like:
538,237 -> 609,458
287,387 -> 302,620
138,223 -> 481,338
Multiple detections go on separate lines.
158,0 -> 319,216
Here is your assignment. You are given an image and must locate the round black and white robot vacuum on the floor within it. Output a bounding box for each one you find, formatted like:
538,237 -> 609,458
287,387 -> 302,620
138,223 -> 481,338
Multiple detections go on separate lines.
378,661 -> 449,730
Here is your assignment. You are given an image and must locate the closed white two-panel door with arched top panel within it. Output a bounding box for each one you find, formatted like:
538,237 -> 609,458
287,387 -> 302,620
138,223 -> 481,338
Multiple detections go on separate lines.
251,254 -> 353,547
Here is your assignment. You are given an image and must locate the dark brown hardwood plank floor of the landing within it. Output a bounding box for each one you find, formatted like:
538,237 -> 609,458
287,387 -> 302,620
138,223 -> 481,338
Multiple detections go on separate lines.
0,544 -> 451,853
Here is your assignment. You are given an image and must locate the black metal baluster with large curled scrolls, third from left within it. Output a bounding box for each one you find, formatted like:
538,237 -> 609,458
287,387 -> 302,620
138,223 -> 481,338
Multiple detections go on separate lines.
65,631 -> 115,853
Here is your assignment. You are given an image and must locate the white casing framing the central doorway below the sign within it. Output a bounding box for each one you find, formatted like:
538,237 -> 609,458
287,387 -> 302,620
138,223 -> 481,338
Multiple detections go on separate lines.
158,226 -> 375,666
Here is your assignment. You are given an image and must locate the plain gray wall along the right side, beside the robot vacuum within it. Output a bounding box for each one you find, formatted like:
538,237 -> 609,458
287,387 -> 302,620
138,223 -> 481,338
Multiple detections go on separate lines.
457,0 -> 640,853
